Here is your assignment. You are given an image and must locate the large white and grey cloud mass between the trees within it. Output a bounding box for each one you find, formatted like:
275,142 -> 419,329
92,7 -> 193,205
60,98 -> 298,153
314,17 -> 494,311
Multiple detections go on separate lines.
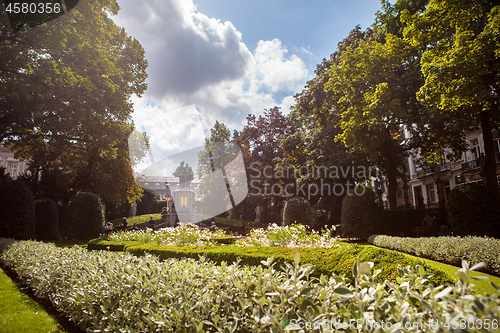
114,0 -> 312,159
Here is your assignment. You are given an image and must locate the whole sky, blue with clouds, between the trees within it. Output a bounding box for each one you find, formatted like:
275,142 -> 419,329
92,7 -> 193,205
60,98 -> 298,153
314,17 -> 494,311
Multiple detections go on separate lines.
113,0 -> 380,171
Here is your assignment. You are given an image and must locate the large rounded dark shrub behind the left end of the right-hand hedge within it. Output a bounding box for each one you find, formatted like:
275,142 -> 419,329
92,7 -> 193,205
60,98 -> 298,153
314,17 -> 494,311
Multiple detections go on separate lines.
341,188 -> 383,239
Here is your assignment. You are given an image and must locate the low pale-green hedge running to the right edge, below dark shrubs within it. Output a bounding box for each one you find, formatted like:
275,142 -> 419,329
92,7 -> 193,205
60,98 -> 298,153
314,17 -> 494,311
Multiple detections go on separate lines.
368,235 -> 500,276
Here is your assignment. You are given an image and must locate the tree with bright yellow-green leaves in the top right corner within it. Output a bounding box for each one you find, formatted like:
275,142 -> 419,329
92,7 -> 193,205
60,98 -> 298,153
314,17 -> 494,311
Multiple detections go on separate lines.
402,0 -> 500,199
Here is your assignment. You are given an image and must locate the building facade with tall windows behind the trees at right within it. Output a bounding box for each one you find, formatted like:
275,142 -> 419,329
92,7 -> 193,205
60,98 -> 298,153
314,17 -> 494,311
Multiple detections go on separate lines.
398,130 -> 500,208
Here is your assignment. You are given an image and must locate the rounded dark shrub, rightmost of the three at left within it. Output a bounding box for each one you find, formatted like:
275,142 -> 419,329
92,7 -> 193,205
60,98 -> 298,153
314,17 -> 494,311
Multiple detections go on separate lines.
61,192 -> 104,239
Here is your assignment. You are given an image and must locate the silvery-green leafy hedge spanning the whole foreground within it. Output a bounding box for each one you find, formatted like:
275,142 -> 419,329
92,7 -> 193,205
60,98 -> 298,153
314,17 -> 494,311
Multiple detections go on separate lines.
0,239 -> 500,332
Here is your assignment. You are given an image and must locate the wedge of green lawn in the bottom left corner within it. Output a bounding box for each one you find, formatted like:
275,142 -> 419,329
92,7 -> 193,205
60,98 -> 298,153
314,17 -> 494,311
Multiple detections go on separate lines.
0,269 -> 68,333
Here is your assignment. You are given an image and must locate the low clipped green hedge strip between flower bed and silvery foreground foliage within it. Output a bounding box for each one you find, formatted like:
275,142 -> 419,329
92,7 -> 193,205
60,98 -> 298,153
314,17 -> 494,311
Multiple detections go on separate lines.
88,240 -> 454,285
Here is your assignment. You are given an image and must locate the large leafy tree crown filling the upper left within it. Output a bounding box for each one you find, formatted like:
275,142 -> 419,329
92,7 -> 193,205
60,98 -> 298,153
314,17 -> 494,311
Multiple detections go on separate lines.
0,0 -> 147,201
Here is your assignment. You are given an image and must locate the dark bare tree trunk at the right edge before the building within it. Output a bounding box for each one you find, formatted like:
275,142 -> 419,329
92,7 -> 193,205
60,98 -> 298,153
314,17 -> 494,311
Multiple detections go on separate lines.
480,111 -> 500,203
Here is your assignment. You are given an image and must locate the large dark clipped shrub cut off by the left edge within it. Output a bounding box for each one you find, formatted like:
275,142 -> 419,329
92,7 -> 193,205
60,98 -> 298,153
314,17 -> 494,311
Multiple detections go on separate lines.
0,179 -> 35,239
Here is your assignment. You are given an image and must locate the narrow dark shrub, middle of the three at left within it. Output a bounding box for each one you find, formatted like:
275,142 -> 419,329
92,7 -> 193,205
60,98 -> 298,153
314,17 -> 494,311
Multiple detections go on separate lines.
35,198 -> 60,241
